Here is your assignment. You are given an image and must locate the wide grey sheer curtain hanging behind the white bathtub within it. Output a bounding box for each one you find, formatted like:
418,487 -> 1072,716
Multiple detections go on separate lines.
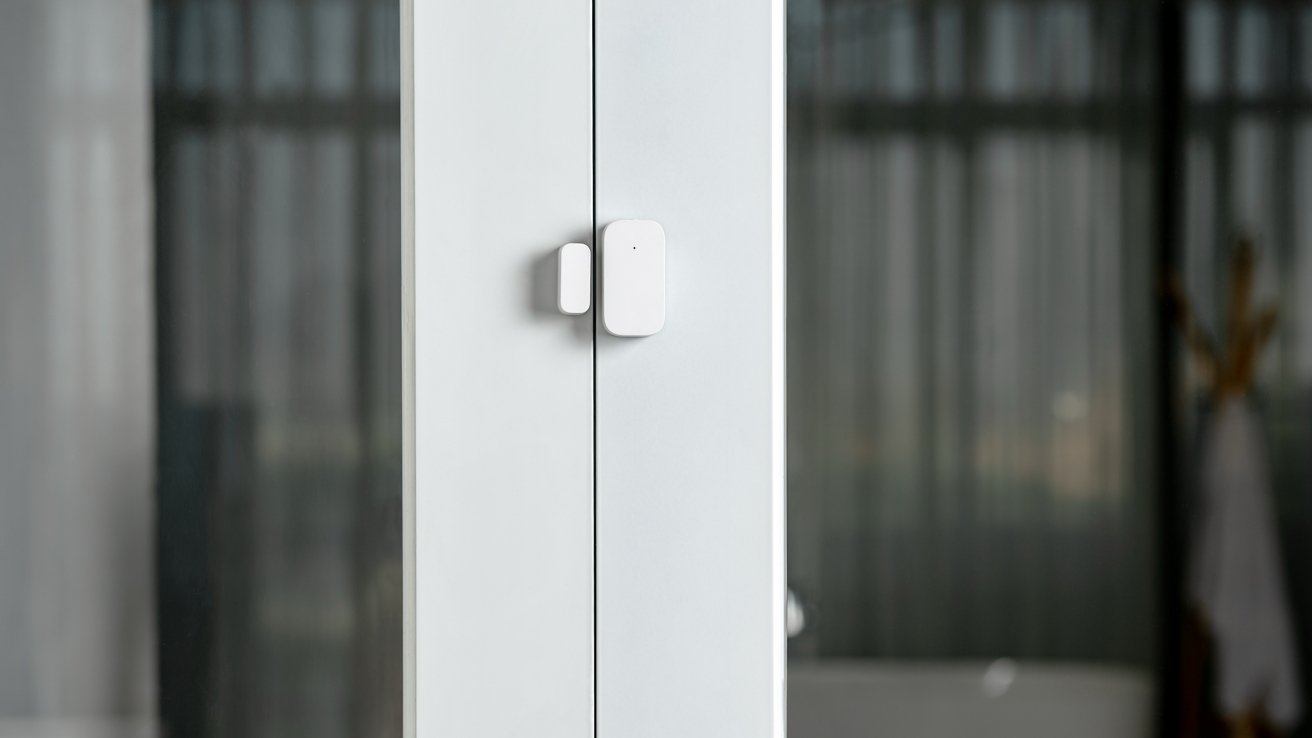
789,0 -> 1155,666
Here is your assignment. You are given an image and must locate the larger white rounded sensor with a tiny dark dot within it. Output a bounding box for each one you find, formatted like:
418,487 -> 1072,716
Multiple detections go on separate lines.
601,221 -> 665,336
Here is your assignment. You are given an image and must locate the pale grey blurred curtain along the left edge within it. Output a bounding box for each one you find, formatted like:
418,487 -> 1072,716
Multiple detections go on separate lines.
0,0 -> 155,737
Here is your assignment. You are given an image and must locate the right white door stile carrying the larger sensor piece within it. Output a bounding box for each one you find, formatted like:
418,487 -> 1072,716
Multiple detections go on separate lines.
596,0 -> 785,738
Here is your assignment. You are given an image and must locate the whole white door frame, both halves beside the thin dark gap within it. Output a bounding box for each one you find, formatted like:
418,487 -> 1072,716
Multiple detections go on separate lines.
401,0 -> 786,738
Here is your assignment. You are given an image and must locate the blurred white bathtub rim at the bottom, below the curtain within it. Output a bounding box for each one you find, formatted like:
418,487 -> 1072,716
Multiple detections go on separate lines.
789,661 -> 1153,738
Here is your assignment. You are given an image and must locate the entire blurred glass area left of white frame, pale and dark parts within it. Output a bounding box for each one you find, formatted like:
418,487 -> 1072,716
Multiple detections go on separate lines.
0,0 -> 401,737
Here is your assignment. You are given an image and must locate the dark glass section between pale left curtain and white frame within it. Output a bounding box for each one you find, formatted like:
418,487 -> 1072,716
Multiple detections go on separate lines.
151,0 -> 403,737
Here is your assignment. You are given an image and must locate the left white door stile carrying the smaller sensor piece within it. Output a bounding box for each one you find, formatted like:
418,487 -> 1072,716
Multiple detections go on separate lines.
413,0 -> 593,738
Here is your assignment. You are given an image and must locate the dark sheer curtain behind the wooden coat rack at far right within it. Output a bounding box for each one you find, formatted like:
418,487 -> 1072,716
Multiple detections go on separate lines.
1177,1 -> 1312,735
